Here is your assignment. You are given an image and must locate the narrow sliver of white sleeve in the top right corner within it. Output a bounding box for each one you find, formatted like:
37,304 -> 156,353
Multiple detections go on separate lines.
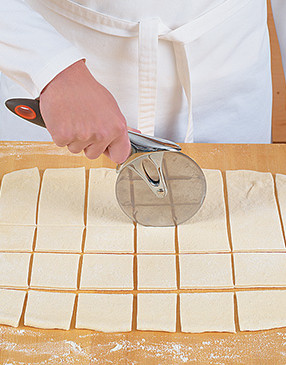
271,0 -> 286,77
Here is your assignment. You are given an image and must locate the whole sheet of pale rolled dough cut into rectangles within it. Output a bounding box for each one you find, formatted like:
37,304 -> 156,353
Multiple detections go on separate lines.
3,168 -> 286,332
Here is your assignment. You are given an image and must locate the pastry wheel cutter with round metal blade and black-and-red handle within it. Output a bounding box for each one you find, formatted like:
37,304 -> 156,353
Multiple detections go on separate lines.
5,99 -> 206,227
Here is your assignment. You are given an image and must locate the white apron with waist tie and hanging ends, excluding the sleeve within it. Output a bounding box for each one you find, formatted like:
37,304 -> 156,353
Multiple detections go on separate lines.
0,0 -> 272,143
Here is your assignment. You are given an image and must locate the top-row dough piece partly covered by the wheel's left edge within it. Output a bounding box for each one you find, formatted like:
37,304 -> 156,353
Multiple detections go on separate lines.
87,168 -> 133,226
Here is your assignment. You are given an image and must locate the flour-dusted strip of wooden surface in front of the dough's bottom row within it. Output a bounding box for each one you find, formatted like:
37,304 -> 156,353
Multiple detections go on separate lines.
0,326 -> 286,365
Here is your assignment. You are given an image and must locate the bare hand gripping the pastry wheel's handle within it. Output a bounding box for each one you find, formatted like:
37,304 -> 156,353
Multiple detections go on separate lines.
40,60 -> 130,163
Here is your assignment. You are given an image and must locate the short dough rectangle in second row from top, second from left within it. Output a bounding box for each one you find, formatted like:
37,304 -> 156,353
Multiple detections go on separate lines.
36,226 -> 84,252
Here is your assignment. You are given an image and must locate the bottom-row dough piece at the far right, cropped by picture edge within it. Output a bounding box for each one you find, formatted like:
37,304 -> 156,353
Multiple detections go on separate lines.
236,290 -> 286,331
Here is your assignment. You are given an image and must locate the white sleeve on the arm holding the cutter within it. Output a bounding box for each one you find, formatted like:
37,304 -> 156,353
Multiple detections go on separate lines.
0,0 -> 85,98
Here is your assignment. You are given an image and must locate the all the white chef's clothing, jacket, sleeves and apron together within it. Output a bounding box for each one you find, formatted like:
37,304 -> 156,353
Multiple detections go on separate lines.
0,0 -> 286,143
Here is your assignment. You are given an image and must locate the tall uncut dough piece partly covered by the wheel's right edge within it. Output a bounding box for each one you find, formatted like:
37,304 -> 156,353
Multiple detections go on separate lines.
178,169 -> 230,253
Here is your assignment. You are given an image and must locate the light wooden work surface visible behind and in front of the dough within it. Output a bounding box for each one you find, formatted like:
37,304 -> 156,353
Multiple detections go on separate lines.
0,142 -> 286,365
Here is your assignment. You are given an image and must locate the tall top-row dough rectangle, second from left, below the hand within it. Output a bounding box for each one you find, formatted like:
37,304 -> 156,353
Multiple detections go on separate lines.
38,167 -> 85,226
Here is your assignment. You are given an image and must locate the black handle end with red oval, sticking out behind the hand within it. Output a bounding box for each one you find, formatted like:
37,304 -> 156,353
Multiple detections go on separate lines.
5,98 -> 46,128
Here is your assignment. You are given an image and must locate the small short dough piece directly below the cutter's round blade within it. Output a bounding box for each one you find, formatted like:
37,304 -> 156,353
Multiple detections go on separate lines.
137,224 -> 175,253
